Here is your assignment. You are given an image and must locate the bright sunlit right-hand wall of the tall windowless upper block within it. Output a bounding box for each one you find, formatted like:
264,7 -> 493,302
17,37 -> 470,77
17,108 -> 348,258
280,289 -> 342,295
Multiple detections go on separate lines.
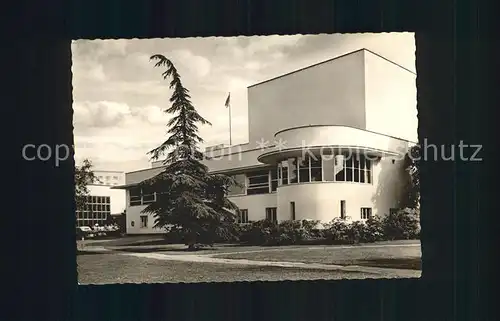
365,51 -> 418,142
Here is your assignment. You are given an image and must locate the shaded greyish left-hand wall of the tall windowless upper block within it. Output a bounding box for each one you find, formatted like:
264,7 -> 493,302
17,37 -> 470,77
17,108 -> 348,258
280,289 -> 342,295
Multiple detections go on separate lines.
248,50 -> 365,146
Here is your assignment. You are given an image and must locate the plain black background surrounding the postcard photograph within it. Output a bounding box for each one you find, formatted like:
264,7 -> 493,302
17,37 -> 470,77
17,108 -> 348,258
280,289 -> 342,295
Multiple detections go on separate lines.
2,0 -> 498,320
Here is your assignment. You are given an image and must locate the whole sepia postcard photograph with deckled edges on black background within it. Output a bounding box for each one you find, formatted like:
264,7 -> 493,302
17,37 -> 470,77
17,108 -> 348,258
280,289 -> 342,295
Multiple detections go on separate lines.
71,32 -> 420,284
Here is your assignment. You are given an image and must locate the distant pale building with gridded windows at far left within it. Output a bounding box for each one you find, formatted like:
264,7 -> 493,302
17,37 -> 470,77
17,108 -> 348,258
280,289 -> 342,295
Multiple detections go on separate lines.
76,170 -> 126,226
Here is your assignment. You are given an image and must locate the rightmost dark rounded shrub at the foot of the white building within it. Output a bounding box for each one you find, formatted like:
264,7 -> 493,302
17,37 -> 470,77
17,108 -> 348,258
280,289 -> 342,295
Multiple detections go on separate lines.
383,208 -> 420,240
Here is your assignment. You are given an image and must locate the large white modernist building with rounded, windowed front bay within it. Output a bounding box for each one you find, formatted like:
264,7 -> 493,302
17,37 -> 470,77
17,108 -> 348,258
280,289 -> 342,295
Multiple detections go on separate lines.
116,49 -> 417,234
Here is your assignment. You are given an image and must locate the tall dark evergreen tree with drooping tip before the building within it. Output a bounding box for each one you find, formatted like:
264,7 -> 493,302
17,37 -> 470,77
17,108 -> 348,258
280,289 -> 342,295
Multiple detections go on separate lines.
141,55 -> 237,249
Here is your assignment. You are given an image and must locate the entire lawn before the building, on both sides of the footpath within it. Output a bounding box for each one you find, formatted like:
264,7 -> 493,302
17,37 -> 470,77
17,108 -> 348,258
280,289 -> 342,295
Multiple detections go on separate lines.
77,240 -> 420,284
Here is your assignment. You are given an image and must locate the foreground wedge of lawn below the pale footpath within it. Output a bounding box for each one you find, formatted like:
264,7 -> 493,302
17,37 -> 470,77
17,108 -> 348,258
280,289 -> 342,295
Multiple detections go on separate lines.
77,253 -> 377,284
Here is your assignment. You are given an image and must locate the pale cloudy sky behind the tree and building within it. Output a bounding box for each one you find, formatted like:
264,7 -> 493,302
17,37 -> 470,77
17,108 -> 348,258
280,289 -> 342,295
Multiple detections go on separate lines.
72,33 -> 415,171
